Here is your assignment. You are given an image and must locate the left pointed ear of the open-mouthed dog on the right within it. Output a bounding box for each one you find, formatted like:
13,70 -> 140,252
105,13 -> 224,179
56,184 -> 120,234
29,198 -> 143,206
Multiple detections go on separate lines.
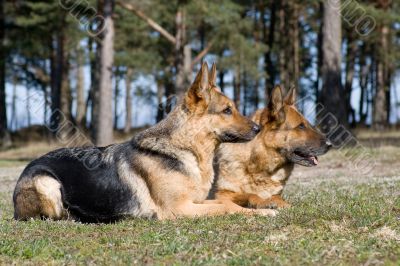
261,85 -> 285,125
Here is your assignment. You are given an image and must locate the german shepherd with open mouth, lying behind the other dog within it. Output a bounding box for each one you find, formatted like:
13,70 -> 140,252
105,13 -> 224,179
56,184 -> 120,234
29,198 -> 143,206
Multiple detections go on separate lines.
214,86 -> 331,209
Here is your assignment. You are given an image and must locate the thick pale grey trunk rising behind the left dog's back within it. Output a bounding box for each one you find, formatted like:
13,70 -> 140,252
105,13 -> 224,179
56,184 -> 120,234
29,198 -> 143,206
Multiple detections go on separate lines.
93,0 -> 114,146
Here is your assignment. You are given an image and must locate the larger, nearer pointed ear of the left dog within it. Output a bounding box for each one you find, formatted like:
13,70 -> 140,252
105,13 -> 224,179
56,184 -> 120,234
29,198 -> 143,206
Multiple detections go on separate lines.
185,62 -> 210,110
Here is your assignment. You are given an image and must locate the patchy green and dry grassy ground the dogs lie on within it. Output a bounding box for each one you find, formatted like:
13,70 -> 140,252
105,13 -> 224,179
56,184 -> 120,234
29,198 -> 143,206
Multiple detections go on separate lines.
0,137 -> 400,265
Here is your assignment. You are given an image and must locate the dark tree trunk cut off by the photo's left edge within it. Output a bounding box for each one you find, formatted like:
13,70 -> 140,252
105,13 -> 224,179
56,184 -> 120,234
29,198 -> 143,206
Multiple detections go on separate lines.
0,1 -> 11,148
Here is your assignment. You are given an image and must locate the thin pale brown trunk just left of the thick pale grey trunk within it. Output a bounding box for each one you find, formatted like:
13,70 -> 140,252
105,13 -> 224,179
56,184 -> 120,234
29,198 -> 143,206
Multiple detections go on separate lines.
76,46 -> 86,128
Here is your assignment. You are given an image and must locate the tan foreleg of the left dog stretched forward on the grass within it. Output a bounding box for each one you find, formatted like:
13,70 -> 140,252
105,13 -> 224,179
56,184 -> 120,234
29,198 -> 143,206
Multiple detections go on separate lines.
175,200 -> 277,217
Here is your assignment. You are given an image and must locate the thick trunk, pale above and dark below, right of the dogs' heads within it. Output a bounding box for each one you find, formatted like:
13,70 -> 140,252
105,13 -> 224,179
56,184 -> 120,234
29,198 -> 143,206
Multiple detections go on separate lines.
318,1 -> 347,133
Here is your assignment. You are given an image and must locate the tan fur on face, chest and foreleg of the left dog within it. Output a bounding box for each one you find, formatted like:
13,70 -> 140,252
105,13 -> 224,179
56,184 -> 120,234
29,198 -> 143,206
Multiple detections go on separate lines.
133,62 -> 275,219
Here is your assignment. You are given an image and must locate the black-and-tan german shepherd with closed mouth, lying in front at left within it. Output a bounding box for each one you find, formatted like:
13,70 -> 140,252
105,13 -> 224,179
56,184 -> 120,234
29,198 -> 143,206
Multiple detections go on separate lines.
13,63 -> 275,222
